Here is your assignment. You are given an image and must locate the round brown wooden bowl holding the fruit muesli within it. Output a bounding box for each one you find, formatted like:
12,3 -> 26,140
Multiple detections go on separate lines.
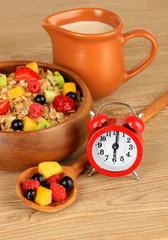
0,61 -> 93,170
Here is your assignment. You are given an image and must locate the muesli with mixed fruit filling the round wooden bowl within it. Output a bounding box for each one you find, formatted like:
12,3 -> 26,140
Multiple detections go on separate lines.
0,62 -> 82,131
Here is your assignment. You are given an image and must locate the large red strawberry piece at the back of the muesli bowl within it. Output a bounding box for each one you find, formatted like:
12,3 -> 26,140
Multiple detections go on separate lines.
15,66 -> 40,81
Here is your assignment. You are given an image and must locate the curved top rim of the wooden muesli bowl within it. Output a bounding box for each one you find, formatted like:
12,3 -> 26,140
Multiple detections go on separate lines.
0,60 -> 91,135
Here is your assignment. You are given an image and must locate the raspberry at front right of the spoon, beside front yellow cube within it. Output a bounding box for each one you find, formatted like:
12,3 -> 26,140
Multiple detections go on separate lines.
50,183 -> 66,202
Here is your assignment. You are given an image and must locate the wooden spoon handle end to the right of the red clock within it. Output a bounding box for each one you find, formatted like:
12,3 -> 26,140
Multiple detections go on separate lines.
138,92 -> 168,122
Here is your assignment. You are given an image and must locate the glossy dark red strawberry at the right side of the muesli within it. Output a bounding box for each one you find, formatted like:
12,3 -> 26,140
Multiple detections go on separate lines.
53,95 -> 76,112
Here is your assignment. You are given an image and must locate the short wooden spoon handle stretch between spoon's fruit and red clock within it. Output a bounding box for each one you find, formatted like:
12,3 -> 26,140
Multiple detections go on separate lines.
71,153 -> 90,178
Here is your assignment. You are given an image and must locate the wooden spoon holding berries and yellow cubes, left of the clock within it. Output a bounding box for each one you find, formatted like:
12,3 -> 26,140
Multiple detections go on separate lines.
16,154 -> 89,212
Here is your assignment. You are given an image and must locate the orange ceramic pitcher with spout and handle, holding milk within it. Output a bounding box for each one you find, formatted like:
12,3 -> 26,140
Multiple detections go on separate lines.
42,8 -> 157,99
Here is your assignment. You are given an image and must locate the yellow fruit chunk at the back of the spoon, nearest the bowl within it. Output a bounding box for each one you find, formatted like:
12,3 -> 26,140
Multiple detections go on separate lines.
38,162 -> 63,179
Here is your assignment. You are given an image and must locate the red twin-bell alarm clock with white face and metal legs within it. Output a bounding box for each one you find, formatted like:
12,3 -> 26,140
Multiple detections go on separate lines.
87,102 -> 144,179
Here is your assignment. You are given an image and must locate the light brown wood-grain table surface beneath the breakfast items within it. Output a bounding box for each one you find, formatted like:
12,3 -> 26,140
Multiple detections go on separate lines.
0,0 -> 168,240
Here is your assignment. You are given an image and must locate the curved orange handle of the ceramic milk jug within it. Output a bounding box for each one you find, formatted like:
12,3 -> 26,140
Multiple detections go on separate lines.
122,29 -> 158,82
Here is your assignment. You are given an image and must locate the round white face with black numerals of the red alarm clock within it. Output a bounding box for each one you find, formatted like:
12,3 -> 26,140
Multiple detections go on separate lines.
92,131 -> 137,172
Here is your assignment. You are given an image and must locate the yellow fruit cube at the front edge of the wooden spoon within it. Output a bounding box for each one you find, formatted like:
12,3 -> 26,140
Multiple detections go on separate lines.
34,186 -> 52,206
